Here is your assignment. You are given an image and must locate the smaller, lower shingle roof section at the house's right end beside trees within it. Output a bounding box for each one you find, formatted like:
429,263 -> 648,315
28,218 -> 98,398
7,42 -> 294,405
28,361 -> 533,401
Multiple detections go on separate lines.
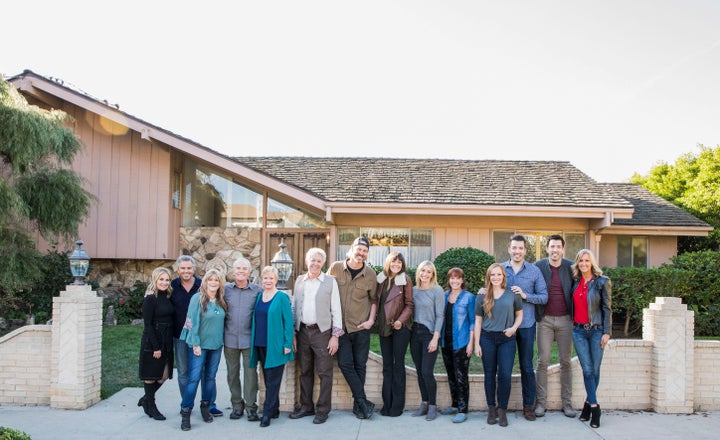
602,183 -> 710,227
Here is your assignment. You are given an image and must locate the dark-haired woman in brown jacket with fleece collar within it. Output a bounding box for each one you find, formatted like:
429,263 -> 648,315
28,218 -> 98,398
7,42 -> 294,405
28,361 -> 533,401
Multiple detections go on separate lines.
377,252 -> 413,417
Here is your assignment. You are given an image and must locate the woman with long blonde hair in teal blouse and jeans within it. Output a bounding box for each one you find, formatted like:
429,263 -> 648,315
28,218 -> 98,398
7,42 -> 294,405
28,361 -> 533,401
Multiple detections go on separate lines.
180,269 -> 227,431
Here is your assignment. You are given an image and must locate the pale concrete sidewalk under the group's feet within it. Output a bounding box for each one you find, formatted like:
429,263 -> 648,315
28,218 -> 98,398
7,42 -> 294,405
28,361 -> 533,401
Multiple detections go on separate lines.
0,360 -> 720,440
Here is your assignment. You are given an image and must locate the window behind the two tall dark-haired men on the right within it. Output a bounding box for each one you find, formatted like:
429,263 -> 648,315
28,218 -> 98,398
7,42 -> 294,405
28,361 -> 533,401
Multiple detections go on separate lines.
493,231 -> 585,263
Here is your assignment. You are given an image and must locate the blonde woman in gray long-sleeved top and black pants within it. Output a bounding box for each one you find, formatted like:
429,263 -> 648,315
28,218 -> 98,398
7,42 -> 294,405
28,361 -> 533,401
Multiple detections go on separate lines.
410,261 -> 445,421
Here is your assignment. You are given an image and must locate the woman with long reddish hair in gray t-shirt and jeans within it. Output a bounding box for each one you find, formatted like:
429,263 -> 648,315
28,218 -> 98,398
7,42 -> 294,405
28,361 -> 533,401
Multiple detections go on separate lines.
475,263 -> 522,426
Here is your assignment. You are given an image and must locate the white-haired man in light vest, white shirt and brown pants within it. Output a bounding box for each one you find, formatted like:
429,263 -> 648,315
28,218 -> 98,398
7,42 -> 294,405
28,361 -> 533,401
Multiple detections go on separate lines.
290,248 -> 343,425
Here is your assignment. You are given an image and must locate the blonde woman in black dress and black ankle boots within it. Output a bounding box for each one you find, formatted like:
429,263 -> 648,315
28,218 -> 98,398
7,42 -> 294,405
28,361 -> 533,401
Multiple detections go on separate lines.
138,267 -> 175,420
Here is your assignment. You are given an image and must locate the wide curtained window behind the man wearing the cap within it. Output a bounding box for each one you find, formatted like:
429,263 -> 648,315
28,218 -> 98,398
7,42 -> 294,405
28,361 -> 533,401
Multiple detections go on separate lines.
337,227 -> 433,267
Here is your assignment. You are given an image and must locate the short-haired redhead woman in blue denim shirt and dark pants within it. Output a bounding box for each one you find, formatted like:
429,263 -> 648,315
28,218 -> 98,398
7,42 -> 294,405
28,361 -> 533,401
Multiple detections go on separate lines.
440,267 -> 475,423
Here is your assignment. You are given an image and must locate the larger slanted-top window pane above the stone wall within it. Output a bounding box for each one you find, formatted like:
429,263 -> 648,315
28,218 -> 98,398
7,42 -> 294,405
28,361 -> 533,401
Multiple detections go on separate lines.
183,159 -> 264,227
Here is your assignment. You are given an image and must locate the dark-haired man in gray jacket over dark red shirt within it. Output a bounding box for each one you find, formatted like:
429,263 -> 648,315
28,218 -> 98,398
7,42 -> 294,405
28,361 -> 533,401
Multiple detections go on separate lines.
535,235 -> 576,417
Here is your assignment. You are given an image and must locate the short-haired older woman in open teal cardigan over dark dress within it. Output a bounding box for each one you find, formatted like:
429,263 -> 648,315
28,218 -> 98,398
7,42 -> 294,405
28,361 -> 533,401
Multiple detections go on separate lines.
250,266 -> 295,428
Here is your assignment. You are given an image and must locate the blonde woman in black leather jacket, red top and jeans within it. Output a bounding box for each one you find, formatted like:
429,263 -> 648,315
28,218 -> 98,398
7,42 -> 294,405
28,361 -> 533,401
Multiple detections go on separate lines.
572,249 -> 612,428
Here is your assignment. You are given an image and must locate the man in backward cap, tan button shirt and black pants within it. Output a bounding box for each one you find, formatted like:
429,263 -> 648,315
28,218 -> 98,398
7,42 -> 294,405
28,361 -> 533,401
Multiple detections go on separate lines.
328,237 -> 377,419
